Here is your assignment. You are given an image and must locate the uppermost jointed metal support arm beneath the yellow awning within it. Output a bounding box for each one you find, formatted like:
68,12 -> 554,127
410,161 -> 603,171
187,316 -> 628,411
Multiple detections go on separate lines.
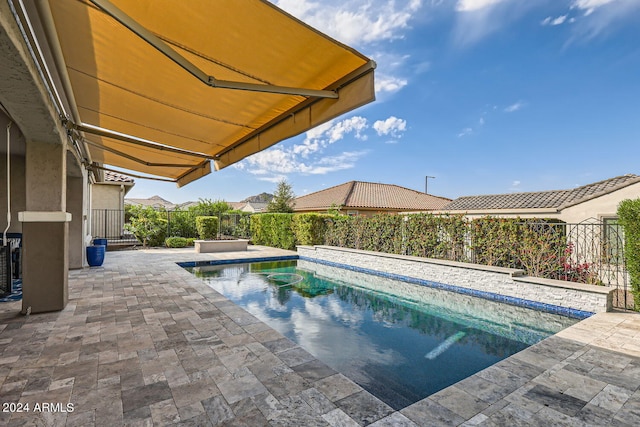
90,0 -> 338,99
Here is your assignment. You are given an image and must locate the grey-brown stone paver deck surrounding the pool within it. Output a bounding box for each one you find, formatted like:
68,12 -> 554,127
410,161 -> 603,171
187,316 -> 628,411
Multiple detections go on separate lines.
0,247 -> 640,426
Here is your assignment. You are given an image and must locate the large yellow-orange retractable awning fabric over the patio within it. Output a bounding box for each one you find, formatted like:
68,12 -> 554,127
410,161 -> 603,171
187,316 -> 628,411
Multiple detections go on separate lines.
39,0 -> 374,185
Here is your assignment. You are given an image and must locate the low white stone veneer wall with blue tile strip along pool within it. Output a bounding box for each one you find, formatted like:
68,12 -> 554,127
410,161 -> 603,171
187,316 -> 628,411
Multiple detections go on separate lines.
297,246 -> 614,318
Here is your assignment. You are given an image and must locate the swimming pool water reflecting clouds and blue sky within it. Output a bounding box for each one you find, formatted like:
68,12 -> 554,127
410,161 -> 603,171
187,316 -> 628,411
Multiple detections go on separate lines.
187,260 -> 577,410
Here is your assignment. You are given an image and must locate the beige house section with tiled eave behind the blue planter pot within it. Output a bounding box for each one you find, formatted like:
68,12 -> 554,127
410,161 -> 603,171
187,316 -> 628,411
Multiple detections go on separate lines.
91,171 -> 135,239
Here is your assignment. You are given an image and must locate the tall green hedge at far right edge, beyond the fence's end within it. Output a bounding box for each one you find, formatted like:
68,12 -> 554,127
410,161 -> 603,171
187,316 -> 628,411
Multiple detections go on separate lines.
618,199 -> 640,311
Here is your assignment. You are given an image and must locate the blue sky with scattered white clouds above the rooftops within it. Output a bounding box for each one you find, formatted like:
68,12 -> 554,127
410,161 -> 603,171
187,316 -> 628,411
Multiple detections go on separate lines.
127,0 -> 640,203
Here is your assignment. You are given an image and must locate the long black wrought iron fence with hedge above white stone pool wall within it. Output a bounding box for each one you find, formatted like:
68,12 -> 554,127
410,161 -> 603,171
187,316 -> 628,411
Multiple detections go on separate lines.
326,215 -> 633,308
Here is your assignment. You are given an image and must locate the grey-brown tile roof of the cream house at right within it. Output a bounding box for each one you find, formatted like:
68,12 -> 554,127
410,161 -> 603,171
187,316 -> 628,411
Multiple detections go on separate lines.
443,174 -> 640,211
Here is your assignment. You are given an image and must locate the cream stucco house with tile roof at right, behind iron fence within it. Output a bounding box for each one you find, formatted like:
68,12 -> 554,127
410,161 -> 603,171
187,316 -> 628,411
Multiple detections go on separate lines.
442,174 -> 640,290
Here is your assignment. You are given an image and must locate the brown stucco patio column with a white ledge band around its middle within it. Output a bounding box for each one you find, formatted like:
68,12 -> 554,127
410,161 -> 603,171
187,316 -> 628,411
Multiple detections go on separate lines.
18,140 -> 71,313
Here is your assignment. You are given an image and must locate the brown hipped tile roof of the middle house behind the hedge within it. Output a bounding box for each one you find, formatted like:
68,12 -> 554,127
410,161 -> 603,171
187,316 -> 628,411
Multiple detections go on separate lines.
293,181 -> 451,215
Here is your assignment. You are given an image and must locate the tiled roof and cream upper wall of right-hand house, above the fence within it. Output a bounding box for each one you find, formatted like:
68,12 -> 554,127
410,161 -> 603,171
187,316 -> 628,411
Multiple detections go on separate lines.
442,174 -> 640,223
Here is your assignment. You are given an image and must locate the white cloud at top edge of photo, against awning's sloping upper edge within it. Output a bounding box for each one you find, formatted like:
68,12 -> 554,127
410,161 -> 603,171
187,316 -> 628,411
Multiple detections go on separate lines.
274,0 -> 422,45
